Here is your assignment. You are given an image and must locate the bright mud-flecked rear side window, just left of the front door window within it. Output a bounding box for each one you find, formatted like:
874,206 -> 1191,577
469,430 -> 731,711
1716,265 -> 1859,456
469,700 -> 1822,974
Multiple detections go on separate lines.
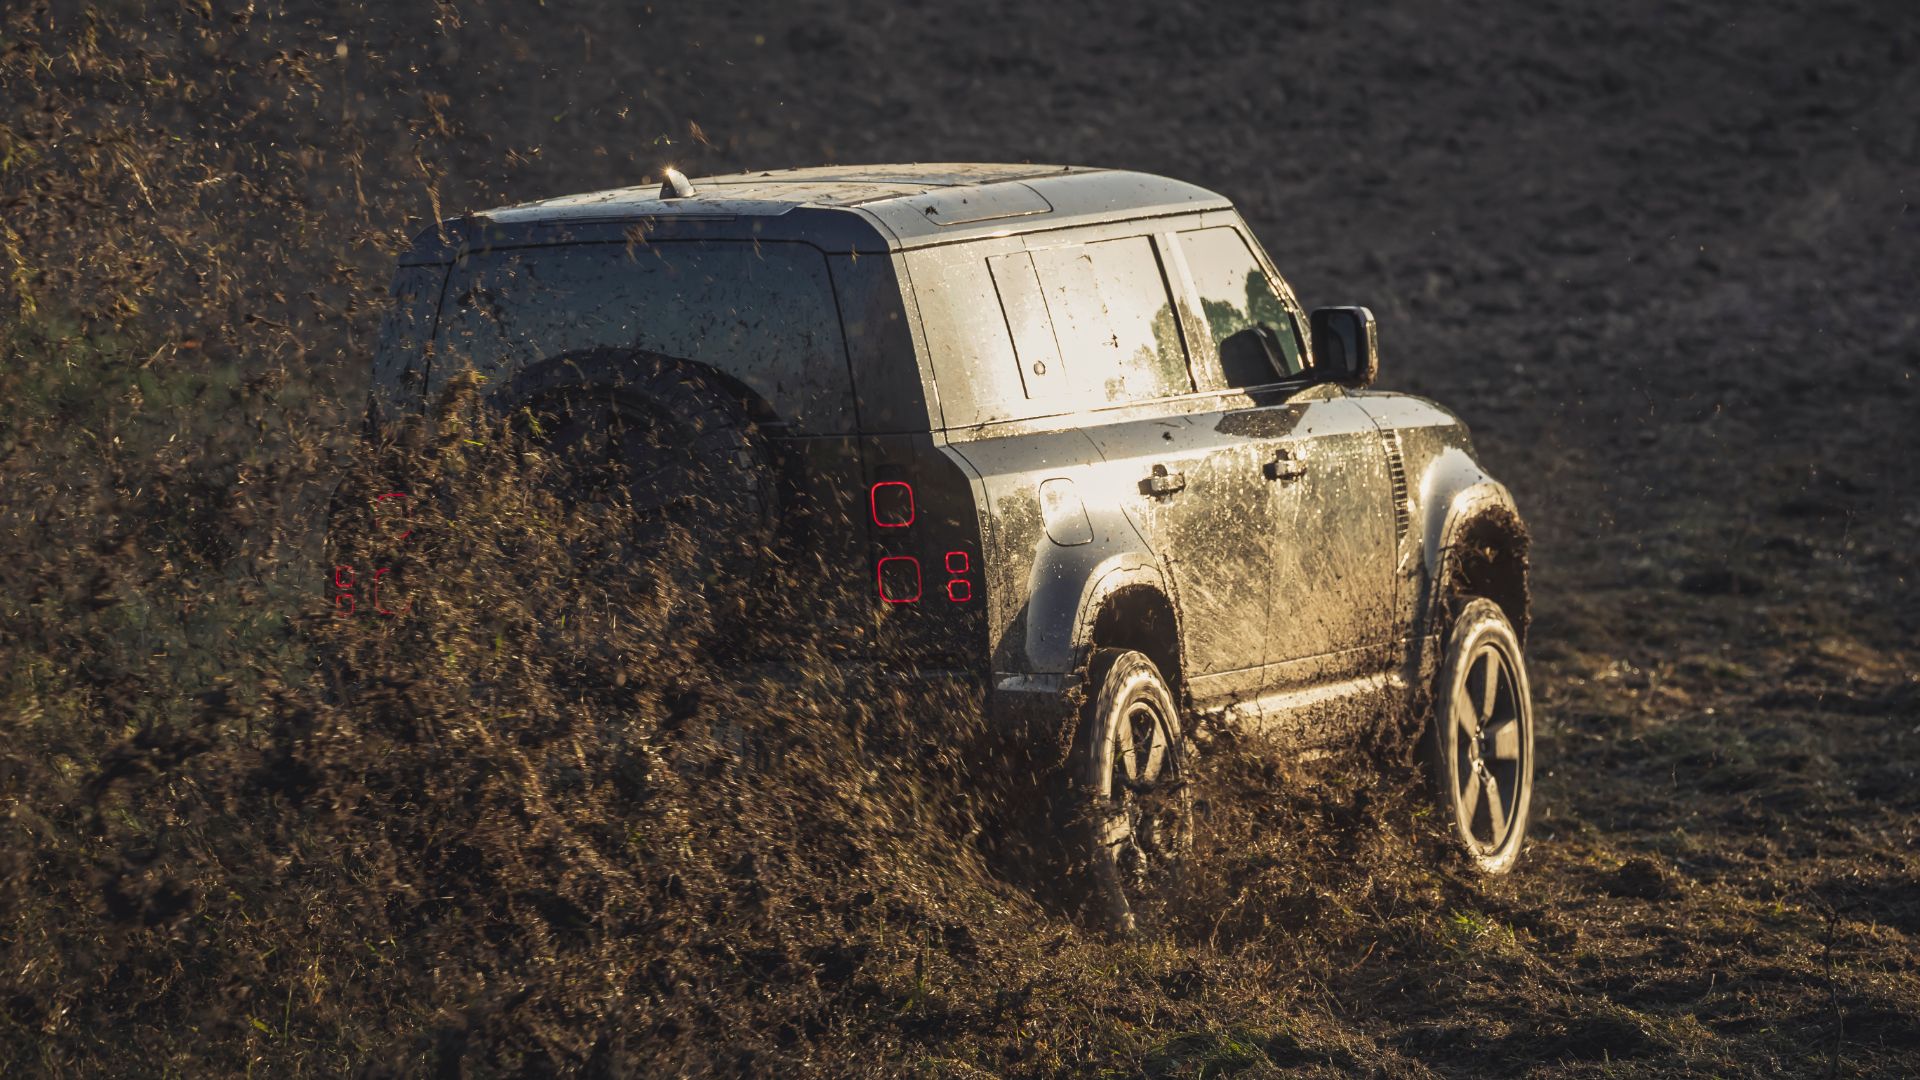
1021,236 -> 1192,404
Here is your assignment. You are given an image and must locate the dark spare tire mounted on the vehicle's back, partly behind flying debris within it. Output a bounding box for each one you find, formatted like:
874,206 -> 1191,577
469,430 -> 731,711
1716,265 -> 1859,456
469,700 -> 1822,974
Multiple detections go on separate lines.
507,354 -> 780,644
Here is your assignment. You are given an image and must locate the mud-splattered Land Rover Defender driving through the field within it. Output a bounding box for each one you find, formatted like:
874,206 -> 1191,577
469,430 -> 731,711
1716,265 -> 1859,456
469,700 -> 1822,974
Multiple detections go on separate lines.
360,165 -> 1532,930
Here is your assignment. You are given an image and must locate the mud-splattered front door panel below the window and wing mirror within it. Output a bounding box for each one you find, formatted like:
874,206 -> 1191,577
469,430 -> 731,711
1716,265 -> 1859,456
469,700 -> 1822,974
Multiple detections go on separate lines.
1265,386 -> 1396,690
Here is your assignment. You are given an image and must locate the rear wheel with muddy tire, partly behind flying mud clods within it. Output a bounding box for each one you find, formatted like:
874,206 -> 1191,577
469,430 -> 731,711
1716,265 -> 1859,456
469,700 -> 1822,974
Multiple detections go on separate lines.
1062,650 -> 1192,934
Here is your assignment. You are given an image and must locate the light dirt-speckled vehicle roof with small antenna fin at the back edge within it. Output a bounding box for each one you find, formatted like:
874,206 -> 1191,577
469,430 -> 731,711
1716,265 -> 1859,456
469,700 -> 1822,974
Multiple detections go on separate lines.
403,163 -> 1231,261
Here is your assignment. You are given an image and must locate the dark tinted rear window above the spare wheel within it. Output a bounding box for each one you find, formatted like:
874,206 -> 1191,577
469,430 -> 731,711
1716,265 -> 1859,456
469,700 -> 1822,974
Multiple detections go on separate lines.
430,240 -> 854,434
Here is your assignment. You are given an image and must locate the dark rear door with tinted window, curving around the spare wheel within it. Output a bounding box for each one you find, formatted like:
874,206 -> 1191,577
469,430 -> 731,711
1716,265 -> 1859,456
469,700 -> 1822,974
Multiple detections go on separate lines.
428,240 -> 871,655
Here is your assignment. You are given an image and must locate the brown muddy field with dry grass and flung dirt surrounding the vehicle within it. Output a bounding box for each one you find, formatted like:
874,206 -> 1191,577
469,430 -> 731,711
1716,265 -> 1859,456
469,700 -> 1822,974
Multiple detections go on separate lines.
0,0 -> 1920,1078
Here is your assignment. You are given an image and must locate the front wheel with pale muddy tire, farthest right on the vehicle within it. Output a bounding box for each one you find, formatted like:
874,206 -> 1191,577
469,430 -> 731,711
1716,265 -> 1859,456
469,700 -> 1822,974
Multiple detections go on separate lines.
1427,600 -> 1534,874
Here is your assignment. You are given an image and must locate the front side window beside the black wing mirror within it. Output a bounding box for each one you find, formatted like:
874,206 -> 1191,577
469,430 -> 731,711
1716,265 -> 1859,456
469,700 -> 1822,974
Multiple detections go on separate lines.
1179,225 -> 1306,386
